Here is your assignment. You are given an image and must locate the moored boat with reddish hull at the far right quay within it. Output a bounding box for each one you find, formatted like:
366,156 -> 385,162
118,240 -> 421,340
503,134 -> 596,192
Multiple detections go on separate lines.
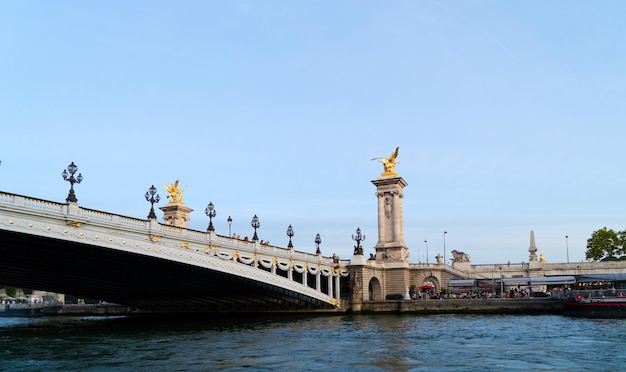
563,289 -> 626,318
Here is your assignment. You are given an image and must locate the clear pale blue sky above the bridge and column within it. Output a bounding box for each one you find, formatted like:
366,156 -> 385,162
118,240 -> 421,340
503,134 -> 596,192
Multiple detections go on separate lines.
0,0 -> 626,264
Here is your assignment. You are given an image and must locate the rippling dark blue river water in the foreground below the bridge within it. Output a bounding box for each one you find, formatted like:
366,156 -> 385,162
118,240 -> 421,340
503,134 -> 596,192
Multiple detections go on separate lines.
0,314 -> 626,371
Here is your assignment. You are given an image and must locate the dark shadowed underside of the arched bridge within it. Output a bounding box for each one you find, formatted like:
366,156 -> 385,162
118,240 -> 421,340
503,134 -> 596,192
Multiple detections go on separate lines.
0,230 -> 335,313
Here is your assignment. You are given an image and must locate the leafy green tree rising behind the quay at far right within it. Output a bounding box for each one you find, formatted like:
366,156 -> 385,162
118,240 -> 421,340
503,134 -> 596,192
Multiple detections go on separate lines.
585,227 -> 626,261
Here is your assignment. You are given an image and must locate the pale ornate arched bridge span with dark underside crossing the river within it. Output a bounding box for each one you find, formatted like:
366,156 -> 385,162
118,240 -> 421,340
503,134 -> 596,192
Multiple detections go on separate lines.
0,192 -> 349,312
